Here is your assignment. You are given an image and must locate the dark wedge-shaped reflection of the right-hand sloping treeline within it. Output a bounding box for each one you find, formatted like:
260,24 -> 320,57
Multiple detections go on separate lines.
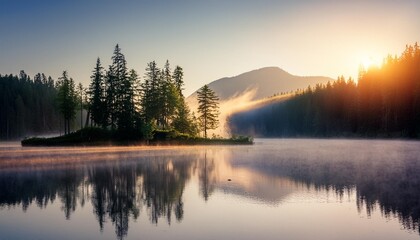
232,148 -> 420,234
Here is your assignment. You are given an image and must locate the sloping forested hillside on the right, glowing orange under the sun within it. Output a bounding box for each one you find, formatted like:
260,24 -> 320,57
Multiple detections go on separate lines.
229,43 -> 420,138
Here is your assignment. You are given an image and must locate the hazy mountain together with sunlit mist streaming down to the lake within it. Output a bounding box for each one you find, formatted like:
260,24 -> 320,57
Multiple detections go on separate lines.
186,67 -> 334,136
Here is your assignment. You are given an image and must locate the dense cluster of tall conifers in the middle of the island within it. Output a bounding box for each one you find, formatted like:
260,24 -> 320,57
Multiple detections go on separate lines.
88,45 -> 198,139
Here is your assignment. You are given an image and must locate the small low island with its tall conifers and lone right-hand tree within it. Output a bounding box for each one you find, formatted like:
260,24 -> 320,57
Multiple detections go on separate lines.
21,45 -> 253,146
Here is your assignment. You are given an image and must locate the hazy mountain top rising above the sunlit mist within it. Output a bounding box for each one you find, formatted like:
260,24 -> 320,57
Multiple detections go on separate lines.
187,67 -> 334,101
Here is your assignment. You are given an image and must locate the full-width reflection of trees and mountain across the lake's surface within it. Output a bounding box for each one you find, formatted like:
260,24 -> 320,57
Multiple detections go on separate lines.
0,141 -> 420,239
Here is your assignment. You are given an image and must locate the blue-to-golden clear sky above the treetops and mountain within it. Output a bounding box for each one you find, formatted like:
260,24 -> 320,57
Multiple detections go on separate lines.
0,0 -> 420,95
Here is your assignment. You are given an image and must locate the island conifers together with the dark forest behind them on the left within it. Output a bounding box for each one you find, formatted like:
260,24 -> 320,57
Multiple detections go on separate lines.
0,44 -> 218,140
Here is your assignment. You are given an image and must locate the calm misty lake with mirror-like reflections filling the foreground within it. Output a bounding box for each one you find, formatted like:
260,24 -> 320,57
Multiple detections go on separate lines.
0,139 -> 420,239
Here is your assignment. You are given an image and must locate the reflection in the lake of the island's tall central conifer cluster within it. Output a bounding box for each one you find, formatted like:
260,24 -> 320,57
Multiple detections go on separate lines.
88,157 -> 191,238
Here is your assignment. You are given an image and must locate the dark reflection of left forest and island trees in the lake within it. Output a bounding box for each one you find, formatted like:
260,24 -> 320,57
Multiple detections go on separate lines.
0,151 -> 197,238
